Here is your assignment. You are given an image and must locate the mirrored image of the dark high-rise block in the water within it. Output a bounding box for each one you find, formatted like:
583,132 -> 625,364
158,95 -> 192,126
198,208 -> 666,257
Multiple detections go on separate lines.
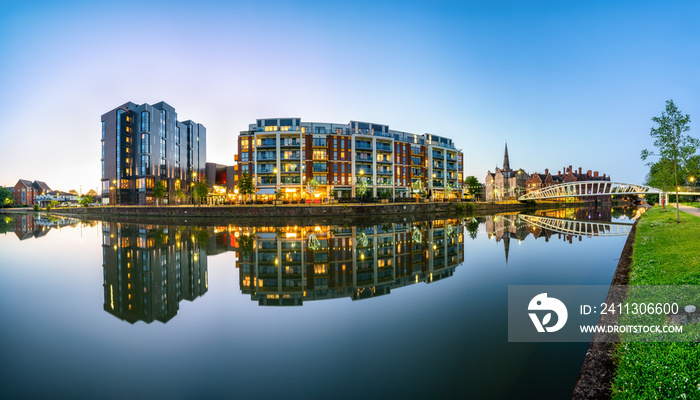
102,222 -> 209,324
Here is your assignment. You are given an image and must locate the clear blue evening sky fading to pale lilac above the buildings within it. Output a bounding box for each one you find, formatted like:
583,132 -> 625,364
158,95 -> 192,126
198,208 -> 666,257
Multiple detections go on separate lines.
0,0 -> 700,192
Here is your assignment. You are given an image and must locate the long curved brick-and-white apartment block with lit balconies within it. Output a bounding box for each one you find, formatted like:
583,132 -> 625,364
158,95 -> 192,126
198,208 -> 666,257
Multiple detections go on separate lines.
235,118 -> 463,199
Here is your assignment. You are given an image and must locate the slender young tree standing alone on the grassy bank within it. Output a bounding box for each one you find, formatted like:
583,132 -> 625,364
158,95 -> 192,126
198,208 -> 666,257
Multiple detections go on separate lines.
641,100 -> 700,223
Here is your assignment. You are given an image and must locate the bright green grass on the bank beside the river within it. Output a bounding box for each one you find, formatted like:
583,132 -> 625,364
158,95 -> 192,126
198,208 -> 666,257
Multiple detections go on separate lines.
613,206 -> 700,399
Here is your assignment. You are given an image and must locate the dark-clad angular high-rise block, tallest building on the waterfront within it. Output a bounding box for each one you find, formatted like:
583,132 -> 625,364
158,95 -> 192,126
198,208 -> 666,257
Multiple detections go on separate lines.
102,101 -> 207,204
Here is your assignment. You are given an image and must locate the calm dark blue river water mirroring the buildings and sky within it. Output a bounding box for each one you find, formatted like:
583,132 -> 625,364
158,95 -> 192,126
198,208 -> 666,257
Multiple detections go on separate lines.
0,209 -> 635,399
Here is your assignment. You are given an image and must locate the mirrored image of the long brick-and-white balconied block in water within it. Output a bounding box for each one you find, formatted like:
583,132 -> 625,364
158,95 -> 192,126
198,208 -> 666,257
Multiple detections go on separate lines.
232,219 -> 464,306
